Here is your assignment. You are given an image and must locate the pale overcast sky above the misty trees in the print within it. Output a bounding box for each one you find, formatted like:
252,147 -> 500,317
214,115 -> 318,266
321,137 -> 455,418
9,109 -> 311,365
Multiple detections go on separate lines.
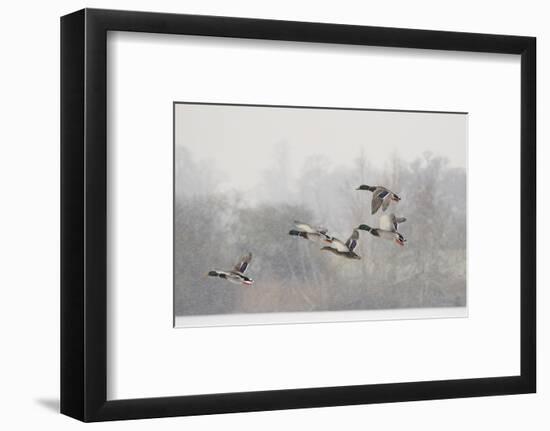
175,104 -> 468,194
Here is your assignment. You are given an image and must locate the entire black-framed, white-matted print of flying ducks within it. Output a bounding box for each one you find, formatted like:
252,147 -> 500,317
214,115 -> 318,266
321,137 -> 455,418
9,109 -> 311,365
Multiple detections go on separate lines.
61,9 -> 536,421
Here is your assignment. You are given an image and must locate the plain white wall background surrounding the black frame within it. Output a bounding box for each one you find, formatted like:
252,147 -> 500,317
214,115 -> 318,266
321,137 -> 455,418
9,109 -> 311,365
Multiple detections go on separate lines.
0,0 -> 550,431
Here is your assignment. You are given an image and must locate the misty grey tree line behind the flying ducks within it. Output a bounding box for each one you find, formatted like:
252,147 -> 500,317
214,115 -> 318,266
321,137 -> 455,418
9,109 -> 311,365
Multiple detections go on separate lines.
174,146 -> 466,315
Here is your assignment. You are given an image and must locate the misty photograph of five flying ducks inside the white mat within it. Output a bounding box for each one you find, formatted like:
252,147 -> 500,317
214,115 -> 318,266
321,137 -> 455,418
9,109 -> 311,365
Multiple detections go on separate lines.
174,102 -> 468,327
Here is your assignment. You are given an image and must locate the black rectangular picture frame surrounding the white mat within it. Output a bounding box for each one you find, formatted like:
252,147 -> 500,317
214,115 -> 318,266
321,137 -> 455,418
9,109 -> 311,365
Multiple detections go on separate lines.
61,9 -> 536,422
